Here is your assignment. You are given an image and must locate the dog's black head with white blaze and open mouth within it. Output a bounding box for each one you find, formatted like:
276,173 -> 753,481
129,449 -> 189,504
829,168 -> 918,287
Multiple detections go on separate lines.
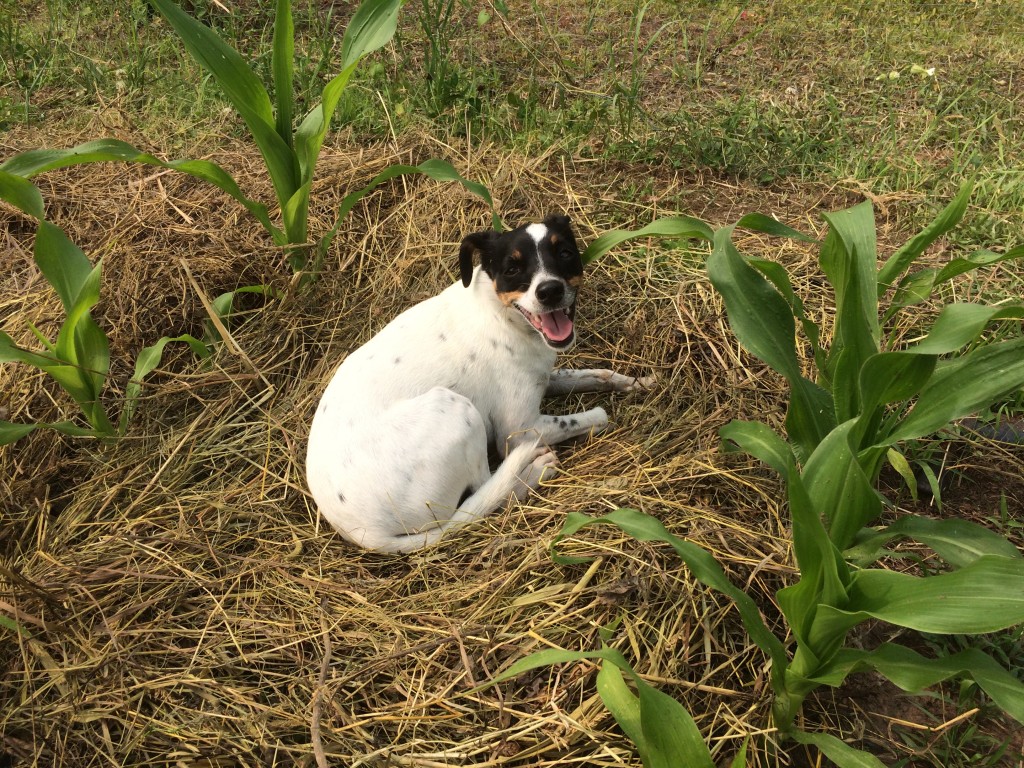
459,215 -> 583,349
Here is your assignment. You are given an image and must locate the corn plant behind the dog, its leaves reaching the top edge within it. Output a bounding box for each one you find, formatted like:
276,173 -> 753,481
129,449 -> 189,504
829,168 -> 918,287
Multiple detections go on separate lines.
0,0 -> 500,271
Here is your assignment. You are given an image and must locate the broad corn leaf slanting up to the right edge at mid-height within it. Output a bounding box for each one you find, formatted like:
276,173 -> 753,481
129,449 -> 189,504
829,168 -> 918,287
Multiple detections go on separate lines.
879,338 -> 1024,445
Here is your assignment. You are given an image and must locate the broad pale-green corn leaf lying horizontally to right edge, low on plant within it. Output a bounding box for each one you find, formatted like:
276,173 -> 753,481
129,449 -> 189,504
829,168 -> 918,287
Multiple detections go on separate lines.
815,555 -> 1024,637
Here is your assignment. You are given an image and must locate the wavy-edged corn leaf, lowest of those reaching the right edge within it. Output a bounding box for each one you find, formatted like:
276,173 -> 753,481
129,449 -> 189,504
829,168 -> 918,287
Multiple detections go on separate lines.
814,643 -> 1024,723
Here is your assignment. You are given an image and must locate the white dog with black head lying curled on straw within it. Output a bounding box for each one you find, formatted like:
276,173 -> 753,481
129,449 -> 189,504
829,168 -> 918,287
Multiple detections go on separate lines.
306,216 -> 647,552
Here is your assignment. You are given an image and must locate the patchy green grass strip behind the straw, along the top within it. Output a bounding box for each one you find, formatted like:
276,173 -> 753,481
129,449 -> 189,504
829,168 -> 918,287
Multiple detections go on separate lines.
8,0 -> 1024,228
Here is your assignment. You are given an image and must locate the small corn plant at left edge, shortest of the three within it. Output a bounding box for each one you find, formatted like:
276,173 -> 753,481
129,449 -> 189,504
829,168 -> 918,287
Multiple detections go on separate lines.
0,171 -> 210,445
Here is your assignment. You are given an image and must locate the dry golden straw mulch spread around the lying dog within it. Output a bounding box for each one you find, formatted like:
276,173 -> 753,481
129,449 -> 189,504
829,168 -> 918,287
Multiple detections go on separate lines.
0,129 -> 1015,768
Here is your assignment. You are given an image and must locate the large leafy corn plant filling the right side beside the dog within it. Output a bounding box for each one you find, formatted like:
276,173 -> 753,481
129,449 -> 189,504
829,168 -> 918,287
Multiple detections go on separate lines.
491,187 -> 1024,768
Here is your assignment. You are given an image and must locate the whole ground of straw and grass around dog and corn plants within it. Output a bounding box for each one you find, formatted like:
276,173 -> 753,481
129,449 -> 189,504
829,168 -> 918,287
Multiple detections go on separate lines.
0,0 -> 1024,768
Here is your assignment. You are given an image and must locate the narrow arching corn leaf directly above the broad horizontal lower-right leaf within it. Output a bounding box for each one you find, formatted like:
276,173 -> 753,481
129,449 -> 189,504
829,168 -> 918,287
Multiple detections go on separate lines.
845,514 -> 1021,568
